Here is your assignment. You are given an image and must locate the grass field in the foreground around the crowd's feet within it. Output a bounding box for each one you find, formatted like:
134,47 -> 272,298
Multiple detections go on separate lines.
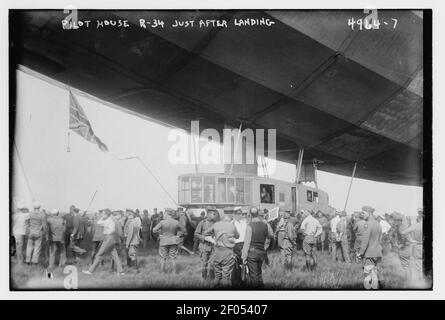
11,244 -> 426,290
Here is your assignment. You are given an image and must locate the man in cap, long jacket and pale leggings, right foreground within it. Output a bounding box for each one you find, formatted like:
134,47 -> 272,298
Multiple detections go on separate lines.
359,206 -> 382,289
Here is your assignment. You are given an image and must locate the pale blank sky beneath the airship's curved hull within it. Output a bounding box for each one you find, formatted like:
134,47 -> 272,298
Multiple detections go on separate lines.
12,71 -> 423,216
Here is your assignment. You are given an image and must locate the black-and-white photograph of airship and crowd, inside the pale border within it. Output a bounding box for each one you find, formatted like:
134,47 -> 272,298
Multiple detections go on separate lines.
6,4 -> 432,296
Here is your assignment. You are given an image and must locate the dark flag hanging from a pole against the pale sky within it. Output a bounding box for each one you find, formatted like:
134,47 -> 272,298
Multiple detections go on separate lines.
70,91 -> 108,152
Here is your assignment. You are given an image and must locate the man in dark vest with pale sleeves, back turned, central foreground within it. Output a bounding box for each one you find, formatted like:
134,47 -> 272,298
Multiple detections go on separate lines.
241,207 -> 273,288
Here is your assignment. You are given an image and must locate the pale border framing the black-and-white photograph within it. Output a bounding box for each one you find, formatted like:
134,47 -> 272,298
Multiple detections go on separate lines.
0,0 -> 445,300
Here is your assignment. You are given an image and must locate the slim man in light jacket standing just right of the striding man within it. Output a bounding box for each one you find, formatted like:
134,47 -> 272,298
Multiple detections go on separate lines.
124,209 -> 142,269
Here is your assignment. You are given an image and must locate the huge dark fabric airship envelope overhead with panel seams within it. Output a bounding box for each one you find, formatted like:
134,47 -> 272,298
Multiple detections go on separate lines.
10,10 -> 423,185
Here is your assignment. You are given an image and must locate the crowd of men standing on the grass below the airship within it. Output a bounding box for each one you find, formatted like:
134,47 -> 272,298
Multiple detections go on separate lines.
12,202 -> 423,288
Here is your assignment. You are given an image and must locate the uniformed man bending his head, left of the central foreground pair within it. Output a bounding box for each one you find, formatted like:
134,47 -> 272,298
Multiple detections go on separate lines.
195,209 -> 219,279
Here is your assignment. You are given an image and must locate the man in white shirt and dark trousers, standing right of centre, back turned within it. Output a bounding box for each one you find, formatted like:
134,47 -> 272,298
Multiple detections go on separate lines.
300,210 -> 323,270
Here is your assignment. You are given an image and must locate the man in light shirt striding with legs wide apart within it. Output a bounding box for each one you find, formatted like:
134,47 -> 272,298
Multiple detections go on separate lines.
82,209 -> 124,276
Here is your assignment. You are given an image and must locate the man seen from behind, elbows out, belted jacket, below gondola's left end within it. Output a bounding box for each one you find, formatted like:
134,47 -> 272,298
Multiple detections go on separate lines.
153,210 -> 185,272
